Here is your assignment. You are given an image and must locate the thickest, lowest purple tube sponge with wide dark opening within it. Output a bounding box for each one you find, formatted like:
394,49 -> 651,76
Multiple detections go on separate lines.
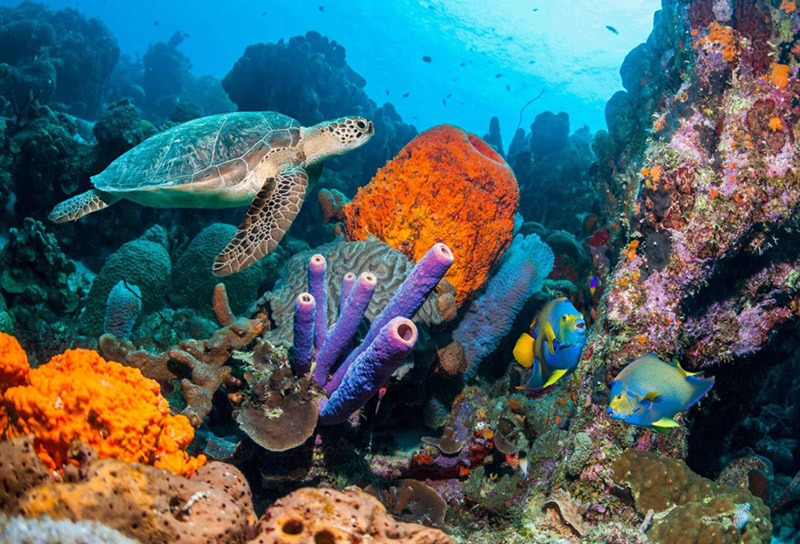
319,316 -> 422,425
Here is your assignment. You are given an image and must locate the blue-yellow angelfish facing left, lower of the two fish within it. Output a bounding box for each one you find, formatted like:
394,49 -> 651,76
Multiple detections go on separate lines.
607,353 -> 714,430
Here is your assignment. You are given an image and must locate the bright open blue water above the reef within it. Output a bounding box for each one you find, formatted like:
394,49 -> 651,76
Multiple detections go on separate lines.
0,0 -> 660,142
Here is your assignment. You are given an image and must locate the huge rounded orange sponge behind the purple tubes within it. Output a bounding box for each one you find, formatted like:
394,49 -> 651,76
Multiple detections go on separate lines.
344,125 -> 519,304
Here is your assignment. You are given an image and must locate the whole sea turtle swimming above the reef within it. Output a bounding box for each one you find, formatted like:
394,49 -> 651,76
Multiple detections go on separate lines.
50,112 -> 375,276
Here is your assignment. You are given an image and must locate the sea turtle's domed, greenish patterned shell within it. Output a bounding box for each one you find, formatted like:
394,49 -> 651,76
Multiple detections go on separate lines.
92,112 -> 301,193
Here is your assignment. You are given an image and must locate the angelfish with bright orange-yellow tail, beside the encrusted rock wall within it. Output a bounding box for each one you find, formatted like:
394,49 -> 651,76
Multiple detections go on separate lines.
514,297 -> 586,389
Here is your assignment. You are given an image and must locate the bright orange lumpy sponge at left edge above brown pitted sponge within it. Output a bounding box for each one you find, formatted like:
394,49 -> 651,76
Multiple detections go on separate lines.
0,333 -> 205,475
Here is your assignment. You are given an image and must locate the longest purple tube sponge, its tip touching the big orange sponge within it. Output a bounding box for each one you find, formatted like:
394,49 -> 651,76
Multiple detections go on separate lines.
324,243 -> 453,394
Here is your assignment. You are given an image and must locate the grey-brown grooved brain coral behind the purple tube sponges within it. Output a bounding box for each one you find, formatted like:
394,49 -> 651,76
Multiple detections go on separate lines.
265,239 -> 452,347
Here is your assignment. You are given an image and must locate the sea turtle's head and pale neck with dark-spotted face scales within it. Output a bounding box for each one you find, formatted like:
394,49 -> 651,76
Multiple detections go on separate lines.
303,117 -> 375,164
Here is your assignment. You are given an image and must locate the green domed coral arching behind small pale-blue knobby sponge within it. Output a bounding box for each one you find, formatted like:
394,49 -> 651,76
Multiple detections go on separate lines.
81,226 -> 170,336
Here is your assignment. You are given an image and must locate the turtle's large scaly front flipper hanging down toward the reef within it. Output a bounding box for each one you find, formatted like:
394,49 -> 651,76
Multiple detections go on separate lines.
212,164 -> 308,276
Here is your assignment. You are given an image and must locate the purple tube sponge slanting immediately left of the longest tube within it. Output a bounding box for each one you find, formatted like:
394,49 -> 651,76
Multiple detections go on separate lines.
314,272 -> 378,385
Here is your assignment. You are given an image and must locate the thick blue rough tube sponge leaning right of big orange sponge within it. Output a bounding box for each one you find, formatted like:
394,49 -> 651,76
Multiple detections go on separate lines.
453,234 -> 554,377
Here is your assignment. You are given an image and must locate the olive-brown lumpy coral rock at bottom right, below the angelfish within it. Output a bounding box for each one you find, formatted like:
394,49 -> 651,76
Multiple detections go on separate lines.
611,450 -> 772,544
